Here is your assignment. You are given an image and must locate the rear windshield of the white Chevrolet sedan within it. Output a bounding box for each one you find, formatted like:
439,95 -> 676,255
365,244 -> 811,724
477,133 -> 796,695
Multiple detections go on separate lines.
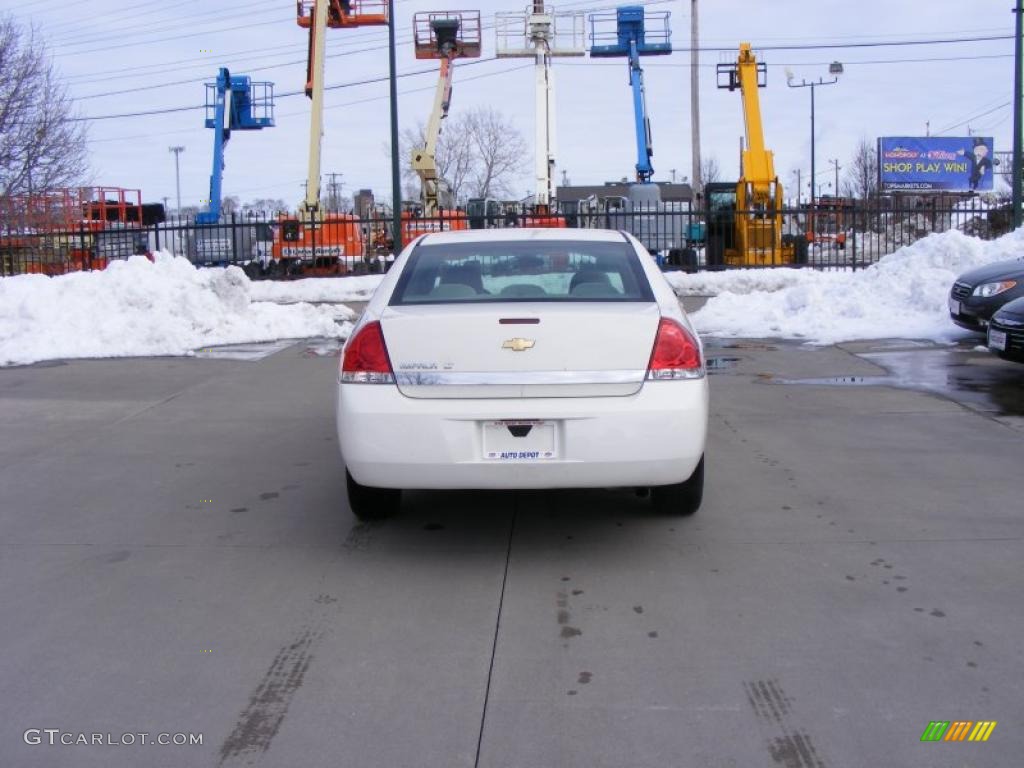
391,240 -> 654,305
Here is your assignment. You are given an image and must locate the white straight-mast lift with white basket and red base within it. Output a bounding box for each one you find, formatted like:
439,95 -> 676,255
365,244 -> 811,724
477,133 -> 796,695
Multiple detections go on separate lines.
495,0 -> 587,226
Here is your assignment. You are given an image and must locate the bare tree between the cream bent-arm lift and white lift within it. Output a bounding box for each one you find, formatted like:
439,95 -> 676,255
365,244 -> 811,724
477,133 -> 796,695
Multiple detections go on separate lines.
466,106 -> 527,198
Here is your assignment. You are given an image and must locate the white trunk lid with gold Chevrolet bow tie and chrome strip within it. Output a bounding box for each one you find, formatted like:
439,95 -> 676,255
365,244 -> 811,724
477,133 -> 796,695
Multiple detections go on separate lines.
381,302 -> 660,398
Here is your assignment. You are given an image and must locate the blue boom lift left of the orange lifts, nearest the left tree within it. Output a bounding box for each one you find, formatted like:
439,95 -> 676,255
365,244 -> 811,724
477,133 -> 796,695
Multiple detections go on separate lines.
185,67 -> 273,266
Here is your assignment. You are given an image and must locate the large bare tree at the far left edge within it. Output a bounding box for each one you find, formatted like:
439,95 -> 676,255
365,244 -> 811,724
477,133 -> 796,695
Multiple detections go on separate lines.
0,16 -> 88,197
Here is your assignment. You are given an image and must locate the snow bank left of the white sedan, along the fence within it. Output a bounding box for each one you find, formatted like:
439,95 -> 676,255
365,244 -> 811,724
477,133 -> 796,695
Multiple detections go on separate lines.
0,252 -> 354,366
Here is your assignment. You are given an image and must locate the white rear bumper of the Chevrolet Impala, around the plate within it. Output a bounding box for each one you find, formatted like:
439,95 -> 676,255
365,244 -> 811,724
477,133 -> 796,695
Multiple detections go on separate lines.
337,378 -> 708,488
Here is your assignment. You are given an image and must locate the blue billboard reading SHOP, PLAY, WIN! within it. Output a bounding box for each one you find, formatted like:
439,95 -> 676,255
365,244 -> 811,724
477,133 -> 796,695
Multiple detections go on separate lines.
879,136 -> 994,191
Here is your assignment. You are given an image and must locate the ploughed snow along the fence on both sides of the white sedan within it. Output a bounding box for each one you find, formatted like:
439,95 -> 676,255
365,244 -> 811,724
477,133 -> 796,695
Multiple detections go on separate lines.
0,230 -> 1024,366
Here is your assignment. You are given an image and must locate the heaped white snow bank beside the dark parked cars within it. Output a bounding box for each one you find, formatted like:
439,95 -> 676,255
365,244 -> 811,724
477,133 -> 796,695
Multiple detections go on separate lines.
677,229 -> 1024,344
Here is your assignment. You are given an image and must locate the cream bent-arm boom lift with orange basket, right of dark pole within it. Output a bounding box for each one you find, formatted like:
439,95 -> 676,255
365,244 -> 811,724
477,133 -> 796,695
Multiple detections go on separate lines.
401,10 -> 480,243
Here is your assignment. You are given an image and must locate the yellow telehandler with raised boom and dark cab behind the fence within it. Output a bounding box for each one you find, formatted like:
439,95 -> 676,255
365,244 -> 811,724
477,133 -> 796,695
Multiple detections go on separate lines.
705,43 -> 807,267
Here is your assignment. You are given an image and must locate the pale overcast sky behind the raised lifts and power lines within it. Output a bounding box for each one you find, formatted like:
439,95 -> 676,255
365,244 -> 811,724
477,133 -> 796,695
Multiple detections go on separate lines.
9,0 -> 1014,206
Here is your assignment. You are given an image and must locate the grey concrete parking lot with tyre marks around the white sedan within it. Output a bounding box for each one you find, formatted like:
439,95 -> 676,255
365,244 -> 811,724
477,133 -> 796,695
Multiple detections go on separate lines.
0,340 -> 1024,768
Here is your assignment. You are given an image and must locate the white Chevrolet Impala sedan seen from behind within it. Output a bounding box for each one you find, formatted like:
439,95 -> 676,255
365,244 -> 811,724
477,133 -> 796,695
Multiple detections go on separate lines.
337,229 -> 708,518
